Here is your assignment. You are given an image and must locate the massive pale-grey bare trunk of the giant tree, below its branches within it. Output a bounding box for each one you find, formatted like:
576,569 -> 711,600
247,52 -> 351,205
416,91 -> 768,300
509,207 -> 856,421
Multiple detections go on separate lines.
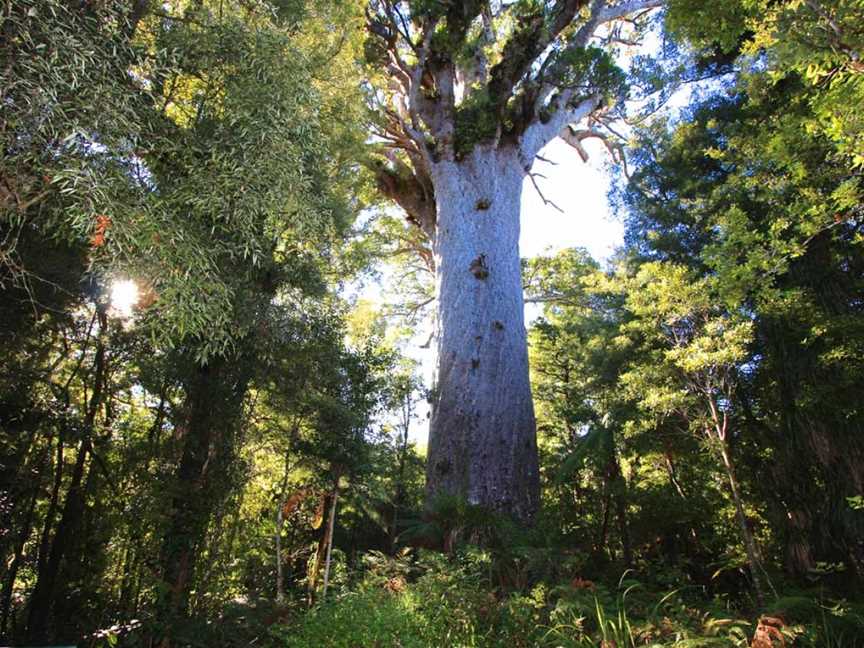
427,146 -> 539,522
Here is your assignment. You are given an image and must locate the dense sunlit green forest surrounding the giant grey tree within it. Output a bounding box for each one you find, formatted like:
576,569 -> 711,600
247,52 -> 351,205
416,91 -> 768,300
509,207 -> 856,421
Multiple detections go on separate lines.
0,0 -> 864,648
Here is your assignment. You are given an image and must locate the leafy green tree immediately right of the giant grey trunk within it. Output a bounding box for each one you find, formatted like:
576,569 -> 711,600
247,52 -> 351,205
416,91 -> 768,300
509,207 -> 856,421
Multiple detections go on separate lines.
526,249 -> 634,567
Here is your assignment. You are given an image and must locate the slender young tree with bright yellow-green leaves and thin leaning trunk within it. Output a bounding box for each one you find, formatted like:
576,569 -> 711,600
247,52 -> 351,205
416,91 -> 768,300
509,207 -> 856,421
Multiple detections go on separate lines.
621,264 -> 765,604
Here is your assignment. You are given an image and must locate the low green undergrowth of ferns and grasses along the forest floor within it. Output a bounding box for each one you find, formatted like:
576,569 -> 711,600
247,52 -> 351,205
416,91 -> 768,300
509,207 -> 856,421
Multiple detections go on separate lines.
270,550 -> 864,648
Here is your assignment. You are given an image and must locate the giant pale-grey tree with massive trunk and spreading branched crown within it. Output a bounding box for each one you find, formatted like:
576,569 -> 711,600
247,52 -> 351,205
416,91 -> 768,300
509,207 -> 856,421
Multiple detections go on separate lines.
367,0 -> 662,520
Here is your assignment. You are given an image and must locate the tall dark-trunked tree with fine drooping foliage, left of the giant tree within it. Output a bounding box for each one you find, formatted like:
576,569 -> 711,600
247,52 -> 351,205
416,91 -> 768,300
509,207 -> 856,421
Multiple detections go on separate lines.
137,3 -> 370,636
